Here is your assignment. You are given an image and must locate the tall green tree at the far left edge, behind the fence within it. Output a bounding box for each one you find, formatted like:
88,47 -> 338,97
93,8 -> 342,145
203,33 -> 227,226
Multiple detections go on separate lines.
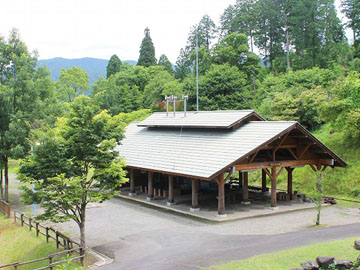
0,30 -> 51,201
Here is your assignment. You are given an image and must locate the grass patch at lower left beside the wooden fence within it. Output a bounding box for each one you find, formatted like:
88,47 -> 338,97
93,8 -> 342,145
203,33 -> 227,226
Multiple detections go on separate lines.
0,214 -> 56,269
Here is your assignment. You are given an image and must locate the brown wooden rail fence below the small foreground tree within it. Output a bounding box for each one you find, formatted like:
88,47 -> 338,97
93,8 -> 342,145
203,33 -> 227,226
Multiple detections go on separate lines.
0,211 -> 85,270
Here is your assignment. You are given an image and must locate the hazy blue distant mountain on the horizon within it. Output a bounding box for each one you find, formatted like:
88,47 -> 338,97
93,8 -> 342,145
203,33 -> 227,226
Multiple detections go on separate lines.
38,57 -> 137,86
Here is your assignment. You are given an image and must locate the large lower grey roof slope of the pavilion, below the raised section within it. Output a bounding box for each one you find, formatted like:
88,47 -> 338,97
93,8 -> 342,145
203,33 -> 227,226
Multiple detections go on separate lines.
116,120 -> 297,179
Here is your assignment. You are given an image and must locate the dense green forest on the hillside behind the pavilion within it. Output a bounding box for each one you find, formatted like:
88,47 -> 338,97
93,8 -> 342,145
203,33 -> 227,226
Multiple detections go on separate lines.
0,0 -> 360,198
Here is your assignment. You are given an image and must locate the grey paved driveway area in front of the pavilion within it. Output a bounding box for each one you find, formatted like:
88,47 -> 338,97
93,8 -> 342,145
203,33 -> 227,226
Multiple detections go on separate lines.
7,174 -> 360,270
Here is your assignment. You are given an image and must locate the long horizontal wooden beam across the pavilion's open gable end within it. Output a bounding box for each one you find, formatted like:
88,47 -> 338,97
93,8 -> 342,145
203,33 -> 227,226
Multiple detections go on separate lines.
235,159 -> 331,171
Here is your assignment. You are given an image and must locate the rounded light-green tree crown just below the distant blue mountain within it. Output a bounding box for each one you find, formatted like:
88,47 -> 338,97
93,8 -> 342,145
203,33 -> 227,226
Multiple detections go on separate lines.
56,67 -> 89,102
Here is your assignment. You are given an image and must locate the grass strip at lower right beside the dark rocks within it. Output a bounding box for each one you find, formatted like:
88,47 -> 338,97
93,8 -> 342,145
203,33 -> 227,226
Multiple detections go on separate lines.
210,238 -> 360,270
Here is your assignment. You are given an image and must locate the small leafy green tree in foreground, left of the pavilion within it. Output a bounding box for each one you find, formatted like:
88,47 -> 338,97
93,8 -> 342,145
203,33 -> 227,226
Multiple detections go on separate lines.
19,96 -> 127,253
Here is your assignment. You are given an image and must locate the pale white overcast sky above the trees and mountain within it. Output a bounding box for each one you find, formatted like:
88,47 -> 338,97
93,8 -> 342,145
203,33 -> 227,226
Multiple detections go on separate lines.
0,0 -> 352,63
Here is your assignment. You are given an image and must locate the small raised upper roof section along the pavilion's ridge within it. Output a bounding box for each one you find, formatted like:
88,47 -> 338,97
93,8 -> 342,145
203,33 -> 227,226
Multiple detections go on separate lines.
138,110 -> 264,128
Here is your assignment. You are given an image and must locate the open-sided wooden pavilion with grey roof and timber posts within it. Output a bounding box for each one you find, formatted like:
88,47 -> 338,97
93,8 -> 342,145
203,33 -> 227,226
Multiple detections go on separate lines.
117,110 -> 347,215
